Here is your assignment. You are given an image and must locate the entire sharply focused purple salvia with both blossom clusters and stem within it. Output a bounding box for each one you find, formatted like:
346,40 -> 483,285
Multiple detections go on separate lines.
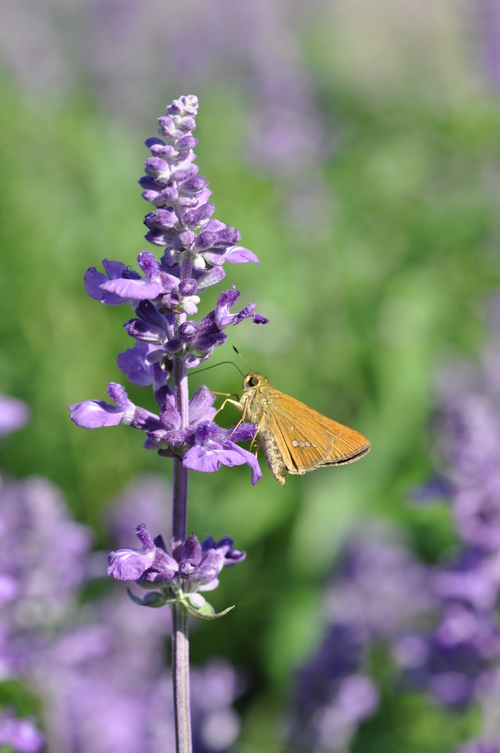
70,96 -> 267,750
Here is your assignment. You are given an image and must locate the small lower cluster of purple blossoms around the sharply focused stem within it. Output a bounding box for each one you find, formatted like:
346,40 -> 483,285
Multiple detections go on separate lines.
108,524 -> 246,594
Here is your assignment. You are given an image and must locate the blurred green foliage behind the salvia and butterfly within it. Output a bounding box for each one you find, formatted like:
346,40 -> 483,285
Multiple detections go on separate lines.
0,4 -> 500,753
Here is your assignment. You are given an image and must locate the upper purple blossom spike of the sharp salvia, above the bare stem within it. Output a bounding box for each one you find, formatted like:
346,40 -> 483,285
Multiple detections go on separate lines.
69,96 -> 267,484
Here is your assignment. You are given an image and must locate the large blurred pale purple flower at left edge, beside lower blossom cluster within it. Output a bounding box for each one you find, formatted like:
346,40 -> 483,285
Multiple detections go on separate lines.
0,477 -> 92,676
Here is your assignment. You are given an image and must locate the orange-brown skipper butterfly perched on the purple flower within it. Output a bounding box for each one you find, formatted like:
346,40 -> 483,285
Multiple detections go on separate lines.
228,371 -> 370,484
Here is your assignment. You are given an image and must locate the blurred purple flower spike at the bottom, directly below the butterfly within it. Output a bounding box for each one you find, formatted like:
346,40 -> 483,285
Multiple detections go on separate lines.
288,525 -> 432,753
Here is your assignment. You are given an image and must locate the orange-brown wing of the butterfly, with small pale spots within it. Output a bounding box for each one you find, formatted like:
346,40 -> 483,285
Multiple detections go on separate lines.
261,388 -> 370,476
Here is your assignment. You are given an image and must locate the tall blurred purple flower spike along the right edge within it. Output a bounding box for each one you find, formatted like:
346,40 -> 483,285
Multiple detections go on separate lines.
394,301 -> 500,707
